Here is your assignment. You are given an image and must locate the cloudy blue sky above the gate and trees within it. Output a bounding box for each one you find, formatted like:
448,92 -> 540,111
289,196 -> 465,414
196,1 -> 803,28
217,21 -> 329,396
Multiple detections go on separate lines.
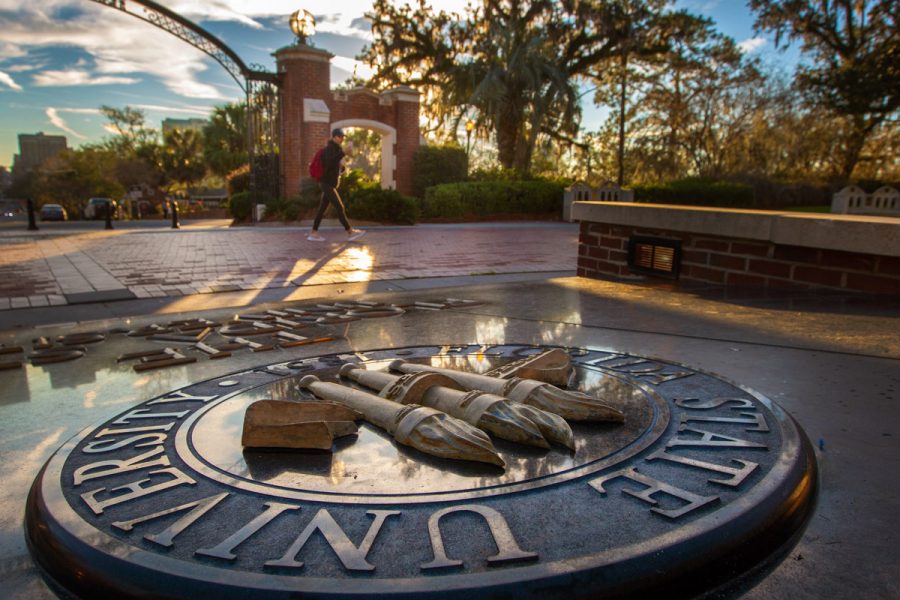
0,0 -> 795,167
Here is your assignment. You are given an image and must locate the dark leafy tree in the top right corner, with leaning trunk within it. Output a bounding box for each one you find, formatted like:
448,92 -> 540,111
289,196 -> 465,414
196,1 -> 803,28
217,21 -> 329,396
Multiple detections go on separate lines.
750,0 -> 900,180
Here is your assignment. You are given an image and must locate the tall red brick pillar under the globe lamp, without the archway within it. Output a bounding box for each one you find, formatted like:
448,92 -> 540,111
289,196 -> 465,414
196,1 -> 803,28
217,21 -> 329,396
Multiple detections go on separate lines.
274,44 -> 334,198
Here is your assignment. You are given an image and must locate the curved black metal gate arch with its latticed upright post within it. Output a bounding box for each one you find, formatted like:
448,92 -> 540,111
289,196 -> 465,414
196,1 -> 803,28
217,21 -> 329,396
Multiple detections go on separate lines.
92,0 -> 282,211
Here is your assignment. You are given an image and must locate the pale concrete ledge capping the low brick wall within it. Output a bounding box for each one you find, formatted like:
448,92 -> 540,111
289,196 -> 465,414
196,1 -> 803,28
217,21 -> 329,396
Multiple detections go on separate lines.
572,201 -> 900,256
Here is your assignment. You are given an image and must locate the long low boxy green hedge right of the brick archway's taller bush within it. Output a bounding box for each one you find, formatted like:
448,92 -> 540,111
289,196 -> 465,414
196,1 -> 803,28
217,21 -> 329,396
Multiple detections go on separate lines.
422,181 -> 565,218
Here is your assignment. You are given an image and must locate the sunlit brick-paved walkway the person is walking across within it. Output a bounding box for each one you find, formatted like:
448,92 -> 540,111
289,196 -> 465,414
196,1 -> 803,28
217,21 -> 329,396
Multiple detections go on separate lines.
0,222 -> 578,310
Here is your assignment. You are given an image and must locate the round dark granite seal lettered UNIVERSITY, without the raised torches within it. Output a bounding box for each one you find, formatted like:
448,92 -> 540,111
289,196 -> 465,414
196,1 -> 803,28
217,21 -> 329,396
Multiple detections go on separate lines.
25,344 -> 817,598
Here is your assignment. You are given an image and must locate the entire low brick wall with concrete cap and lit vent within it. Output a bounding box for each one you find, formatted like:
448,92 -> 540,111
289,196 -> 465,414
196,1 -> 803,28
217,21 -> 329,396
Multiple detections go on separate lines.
572,202 -> 900,296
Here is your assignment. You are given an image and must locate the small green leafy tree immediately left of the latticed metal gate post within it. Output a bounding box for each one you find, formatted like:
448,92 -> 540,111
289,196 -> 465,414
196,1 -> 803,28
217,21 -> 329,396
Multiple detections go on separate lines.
203,103 -> 249,177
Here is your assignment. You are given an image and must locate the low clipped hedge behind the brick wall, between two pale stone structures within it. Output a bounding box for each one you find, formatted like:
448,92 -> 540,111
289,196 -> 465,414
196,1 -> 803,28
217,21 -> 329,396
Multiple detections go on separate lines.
633,178 -> 754,208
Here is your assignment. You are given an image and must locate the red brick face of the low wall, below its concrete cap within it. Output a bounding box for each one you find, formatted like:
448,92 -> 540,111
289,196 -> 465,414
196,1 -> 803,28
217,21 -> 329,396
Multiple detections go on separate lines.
578,221 -> 900,295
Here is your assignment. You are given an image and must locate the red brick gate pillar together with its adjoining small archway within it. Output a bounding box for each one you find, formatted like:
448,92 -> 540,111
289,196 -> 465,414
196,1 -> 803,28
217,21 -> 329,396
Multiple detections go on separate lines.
275,44 -> 420,198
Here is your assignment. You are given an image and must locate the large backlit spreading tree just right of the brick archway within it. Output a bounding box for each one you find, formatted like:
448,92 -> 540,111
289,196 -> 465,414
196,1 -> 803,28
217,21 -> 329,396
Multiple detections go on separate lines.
361,0 -> 627,173
